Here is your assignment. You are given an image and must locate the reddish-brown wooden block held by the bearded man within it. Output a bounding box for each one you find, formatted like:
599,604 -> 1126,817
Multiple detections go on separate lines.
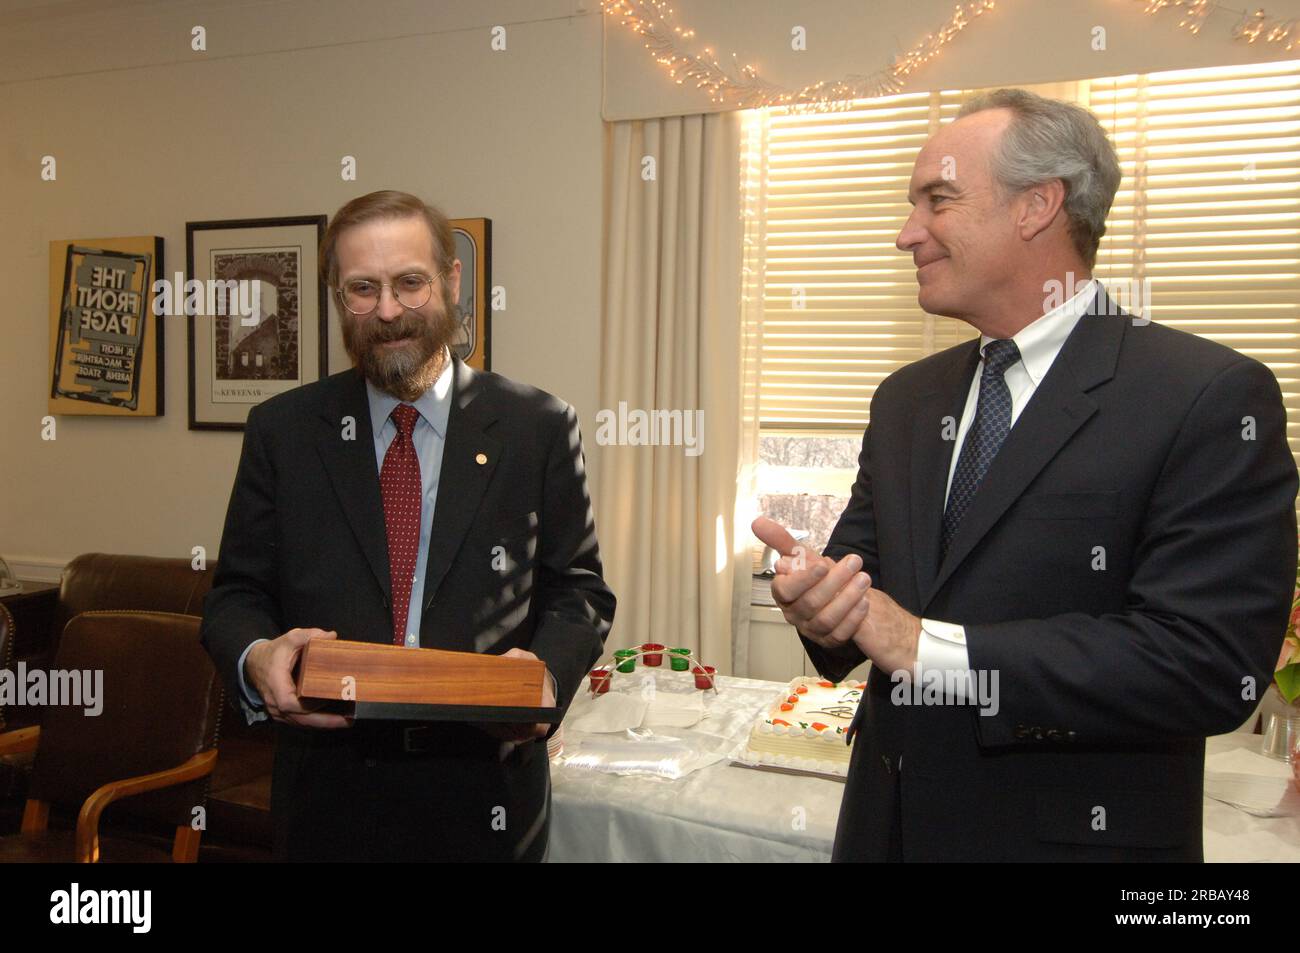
298,638 -> 546,720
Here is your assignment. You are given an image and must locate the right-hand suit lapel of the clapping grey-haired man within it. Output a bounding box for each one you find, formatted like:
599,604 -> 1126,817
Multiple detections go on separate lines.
914,287 -> 1128,606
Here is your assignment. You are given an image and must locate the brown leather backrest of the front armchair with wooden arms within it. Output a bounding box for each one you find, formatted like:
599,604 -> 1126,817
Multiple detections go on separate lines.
30,611 -> 221,826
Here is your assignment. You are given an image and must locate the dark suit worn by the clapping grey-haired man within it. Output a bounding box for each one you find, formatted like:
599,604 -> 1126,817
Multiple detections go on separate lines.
805,291 -> 1297,861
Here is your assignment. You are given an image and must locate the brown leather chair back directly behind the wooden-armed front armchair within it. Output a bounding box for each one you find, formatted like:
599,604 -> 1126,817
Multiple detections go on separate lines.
49,553 -> 216,658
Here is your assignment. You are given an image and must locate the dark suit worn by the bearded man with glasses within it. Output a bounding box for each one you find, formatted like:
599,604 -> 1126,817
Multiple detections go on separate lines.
203,359 -> 615,859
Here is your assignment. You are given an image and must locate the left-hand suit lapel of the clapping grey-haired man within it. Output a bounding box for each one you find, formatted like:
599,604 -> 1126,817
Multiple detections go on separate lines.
911,338 -> 979,606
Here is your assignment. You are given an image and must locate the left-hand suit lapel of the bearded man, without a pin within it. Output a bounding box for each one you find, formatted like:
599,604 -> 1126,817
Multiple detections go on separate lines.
316,368 -> 393,602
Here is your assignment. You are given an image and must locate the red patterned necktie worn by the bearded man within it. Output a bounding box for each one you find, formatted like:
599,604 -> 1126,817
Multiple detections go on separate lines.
380,404 -> 424,645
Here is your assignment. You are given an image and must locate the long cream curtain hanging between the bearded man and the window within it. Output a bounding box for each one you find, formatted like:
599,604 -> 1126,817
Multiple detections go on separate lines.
589,113 -> 750,673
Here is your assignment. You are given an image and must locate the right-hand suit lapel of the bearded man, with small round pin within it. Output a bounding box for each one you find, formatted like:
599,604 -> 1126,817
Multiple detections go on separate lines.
424,358 -> 502,610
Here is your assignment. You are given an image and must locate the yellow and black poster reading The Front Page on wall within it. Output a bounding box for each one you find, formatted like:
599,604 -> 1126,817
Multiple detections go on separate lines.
49,235 -> 164,417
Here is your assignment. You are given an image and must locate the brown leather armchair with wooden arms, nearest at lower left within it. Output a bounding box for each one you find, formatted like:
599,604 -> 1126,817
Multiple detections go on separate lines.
0,611 -> 221,863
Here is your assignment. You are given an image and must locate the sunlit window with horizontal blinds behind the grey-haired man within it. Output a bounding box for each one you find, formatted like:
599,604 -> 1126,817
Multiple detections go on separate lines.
741,61 -> 1300,561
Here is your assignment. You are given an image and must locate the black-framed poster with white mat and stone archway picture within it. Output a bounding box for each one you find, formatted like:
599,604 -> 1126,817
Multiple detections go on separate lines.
185,215 -> 329,430
